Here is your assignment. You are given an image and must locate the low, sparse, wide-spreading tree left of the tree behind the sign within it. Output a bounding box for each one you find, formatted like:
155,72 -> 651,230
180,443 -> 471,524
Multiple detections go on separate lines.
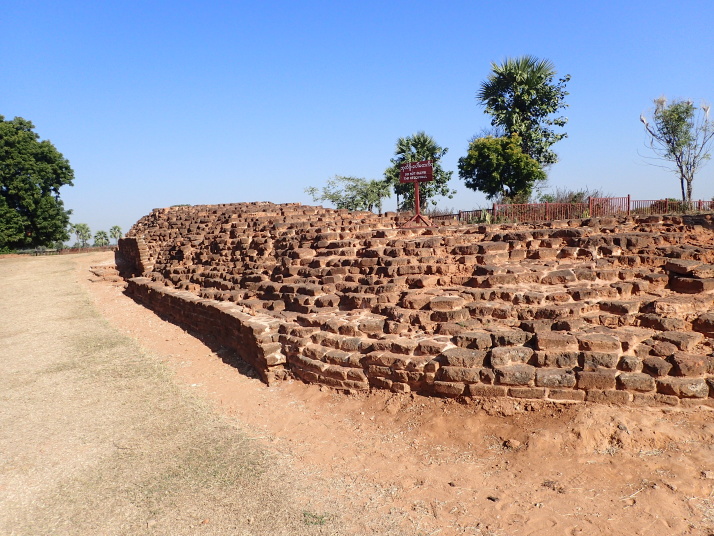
305,175 -> 392,214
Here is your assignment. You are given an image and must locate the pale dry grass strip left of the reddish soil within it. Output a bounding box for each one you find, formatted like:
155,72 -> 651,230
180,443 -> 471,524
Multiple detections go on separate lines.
0,257 -> 358,535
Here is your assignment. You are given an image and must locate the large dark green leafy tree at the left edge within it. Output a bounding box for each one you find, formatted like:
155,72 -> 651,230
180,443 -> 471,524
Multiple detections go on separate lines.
0,115 -> 74,248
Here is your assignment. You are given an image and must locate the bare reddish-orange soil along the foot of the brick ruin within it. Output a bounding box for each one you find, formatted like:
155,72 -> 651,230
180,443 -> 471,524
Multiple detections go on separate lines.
77,253 -> 714,536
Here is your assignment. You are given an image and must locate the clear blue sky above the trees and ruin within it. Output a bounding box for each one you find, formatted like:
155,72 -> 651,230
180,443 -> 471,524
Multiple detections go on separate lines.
0,0 -> 714,236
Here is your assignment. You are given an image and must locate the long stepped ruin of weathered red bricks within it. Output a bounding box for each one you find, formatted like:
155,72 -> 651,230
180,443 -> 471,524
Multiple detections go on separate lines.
117,203 -> 714,406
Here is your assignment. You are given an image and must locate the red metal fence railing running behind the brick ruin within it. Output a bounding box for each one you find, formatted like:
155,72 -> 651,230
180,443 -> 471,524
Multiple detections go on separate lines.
429,195 -> 714,223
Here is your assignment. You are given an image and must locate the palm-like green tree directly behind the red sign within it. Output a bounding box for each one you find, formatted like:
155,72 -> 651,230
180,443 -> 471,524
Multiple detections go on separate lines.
384,132 -> 456,210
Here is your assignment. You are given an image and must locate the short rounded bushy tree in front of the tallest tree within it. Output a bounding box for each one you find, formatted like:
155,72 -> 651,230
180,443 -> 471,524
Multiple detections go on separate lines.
459,135 -> 546,203
